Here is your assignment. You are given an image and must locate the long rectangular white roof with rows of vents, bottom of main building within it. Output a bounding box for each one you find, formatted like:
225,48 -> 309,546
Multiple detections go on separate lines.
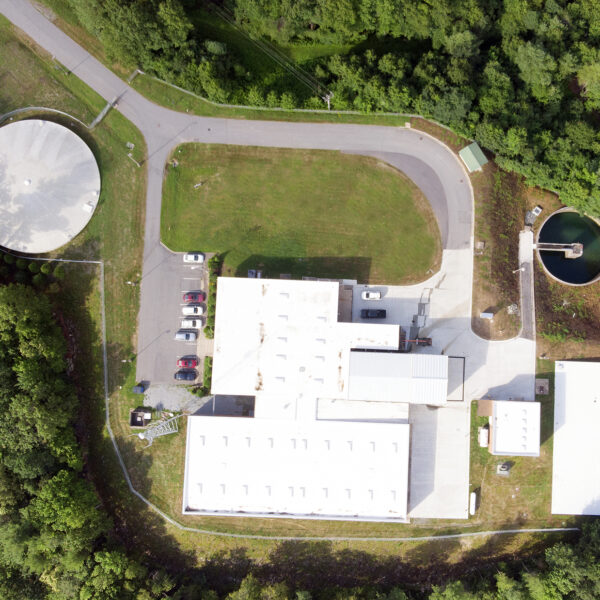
183,416 -> 410,520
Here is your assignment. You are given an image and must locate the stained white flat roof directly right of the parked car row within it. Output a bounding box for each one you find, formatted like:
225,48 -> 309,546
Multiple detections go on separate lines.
211,277 -> 400,399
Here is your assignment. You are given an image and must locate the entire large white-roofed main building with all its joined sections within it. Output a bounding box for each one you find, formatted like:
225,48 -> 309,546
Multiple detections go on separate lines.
183,277 -> 468,521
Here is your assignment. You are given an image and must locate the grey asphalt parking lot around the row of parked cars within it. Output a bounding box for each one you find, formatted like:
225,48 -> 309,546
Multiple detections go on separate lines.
137,247 -> 208,385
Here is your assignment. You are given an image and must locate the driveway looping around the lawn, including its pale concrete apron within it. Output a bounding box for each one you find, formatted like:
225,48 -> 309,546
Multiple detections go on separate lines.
0,0 -> 535,406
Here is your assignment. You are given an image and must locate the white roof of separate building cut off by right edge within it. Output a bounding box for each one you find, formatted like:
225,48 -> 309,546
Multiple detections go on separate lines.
552,361 -> 600,515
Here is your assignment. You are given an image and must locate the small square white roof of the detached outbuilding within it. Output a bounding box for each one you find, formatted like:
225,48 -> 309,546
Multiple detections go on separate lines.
490,400 -> 541,456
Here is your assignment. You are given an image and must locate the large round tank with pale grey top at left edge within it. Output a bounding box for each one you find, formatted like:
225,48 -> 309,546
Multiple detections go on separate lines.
0,119 -> 100,254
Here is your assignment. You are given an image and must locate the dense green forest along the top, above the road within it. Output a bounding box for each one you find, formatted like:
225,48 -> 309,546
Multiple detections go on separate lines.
68,0 -> 600,215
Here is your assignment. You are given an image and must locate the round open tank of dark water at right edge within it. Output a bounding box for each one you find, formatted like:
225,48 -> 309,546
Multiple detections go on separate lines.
538,209 -> 600,285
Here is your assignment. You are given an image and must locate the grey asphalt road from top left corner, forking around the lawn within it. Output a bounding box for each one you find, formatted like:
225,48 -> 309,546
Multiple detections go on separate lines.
0,0 -> 535,396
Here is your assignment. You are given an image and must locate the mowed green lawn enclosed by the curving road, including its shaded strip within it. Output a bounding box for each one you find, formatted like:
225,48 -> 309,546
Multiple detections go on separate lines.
161,144 -> 441,284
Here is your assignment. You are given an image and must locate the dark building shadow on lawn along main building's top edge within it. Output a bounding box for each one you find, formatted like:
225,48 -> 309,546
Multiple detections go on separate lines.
234,254 -> 372,282
